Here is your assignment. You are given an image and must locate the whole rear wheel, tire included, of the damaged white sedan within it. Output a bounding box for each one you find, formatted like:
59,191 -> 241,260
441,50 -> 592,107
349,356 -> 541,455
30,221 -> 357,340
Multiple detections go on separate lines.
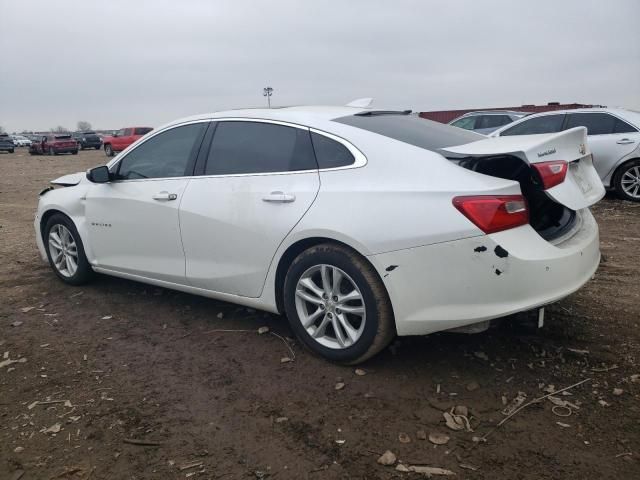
284,243 -> 396,365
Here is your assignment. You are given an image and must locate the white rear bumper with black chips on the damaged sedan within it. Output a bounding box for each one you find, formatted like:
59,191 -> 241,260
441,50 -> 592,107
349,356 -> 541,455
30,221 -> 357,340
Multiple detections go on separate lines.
369,209 -> 600,335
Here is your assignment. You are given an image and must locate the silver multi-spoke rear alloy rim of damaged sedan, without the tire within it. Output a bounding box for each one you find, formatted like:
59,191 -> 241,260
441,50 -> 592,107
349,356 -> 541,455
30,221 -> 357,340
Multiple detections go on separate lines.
295,264 -> 366,349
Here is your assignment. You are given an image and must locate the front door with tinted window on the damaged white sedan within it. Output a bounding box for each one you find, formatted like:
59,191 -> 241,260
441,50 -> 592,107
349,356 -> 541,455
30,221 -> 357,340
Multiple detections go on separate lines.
86,122 -> 207,284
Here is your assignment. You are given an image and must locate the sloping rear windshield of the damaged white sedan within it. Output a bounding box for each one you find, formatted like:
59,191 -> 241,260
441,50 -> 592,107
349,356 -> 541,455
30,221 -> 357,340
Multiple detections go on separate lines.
334,113 -> 486,151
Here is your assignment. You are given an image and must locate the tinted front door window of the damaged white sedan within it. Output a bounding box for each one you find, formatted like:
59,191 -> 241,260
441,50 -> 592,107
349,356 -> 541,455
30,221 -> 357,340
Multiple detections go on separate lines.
117,123 -> 206,180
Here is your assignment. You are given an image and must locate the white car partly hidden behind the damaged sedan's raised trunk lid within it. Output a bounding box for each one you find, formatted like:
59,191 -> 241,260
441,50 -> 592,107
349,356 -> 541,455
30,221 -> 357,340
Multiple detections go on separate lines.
490,108 -> 640,202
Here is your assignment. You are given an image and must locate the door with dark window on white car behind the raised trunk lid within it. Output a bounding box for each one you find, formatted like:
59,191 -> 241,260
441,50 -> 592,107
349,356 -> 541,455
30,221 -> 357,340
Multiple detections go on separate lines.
565,112 -> 640,183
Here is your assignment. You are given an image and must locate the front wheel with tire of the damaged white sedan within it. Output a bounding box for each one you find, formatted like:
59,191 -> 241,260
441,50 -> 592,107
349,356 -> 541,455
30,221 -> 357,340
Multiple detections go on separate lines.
43,213 -> 93,285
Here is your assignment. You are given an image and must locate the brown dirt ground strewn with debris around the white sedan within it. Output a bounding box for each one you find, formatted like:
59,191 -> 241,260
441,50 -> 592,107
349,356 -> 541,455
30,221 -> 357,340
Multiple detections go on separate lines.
0,149 -> 640,480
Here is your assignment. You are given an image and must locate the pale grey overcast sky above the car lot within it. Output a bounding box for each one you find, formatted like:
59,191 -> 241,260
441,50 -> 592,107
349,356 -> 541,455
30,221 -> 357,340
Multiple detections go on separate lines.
0,0 -> 640,131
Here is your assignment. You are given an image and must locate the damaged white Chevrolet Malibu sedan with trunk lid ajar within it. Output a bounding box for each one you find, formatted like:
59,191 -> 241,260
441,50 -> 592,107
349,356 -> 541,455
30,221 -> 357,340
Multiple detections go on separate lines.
35,102 -> 604,364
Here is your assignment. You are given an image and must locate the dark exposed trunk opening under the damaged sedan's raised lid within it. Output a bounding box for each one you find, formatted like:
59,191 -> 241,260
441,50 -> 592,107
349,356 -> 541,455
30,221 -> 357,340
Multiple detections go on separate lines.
450,155 -> 576,240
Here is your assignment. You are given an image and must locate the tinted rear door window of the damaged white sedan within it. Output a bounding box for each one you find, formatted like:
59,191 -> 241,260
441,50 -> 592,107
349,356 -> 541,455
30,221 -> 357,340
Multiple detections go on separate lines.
205,122 -> 318,175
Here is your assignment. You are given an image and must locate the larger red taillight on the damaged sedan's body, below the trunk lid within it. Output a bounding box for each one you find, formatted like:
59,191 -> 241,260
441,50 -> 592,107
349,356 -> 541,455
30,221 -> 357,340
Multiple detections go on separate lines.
453,195 -> 529,233
